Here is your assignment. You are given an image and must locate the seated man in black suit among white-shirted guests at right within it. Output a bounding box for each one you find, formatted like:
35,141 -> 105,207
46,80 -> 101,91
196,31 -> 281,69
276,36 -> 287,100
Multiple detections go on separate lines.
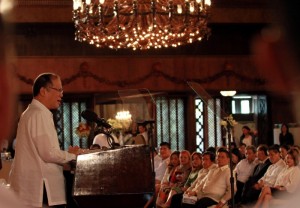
241,145 -> 272,204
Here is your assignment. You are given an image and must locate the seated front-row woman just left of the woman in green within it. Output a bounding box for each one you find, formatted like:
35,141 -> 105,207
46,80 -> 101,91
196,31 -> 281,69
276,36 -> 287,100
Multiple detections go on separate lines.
158,150 -> 192,208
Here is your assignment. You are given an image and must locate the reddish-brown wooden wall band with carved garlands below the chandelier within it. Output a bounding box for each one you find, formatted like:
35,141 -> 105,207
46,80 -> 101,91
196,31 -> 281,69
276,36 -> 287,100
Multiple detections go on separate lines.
11,56 -> 267,93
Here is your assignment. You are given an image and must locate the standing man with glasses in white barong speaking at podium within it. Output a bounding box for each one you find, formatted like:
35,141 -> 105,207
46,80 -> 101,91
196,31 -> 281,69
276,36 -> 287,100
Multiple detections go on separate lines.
10,73 -> 79,207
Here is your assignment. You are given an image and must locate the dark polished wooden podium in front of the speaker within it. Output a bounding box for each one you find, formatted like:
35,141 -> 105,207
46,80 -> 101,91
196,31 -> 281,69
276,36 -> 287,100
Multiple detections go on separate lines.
73,145 -> 154,208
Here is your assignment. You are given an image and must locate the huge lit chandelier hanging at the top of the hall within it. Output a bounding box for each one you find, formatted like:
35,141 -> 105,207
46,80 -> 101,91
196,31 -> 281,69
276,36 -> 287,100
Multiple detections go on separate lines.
73,0 -> 211,50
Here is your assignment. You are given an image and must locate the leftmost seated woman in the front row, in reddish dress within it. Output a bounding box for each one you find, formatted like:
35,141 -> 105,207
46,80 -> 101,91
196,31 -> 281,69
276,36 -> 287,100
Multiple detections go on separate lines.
155,151 -> 180,207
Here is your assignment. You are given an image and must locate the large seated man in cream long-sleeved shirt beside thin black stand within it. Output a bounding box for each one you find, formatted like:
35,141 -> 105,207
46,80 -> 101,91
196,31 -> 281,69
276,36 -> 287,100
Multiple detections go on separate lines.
182,148 -> 236,208
